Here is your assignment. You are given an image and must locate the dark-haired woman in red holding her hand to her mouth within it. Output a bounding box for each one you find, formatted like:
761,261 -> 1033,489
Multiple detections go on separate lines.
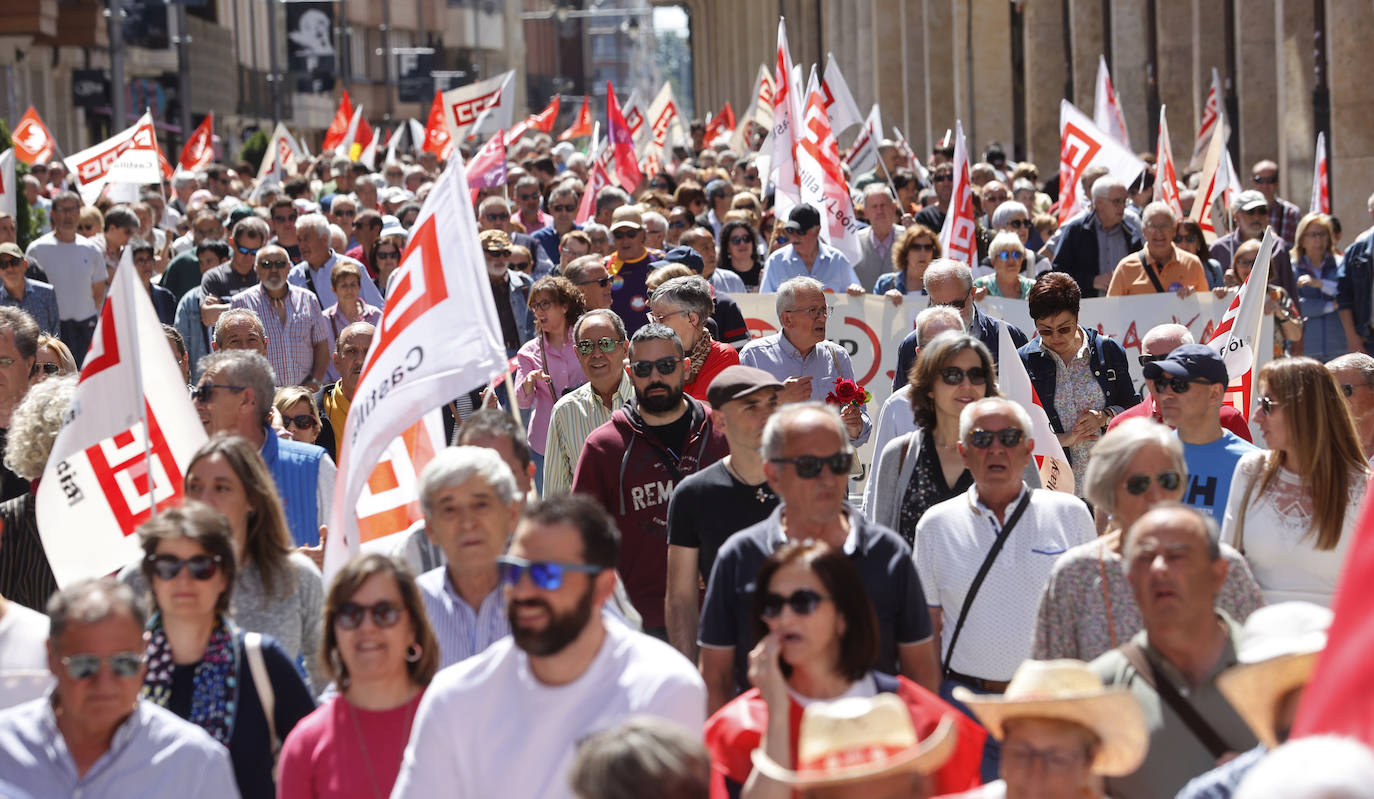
706,541 -> 987,799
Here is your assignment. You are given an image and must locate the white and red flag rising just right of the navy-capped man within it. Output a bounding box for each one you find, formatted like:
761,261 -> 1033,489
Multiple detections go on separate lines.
1206,228 -> 1278,420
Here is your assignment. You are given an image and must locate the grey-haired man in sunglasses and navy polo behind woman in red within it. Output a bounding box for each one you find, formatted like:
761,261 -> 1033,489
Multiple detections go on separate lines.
698,402 -> 940,713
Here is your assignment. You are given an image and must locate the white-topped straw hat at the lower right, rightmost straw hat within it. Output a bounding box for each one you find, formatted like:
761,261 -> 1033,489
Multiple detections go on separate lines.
1216,601 -> 1331,750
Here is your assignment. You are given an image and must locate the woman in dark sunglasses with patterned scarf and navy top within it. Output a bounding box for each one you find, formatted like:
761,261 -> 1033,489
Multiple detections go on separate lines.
139,501 -> 315,796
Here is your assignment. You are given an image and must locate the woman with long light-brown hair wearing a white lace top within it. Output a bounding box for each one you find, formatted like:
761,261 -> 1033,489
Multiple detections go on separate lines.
1221,357 -> 1369,607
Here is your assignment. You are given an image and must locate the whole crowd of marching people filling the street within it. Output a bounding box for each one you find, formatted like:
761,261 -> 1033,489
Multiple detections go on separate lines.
0,112 -> 1374,799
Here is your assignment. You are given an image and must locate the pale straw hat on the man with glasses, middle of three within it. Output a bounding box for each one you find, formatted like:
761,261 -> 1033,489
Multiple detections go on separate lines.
954,660 -> 1149,777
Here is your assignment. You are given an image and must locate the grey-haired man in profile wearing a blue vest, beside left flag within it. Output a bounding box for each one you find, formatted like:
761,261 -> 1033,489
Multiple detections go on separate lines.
191,350 -> 337,546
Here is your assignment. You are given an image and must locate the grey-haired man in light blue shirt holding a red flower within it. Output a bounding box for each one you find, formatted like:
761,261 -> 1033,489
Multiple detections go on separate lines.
739,277 -> 872,446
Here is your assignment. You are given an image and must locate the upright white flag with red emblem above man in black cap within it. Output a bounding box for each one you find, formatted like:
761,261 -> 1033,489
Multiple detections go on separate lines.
797,67 -> 863,264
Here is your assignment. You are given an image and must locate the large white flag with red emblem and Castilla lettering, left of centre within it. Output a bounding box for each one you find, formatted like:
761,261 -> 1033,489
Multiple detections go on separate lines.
324,148 -> 506,582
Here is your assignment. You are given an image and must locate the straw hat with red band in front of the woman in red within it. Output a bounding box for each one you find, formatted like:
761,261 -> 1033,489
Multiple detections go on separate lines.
753,693 -> 958,788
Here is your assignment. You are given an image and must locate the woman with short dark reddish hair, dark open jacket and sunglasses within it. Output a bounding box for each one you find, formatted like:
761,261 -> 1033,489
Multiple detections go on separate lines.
1017,272 -> 1140,494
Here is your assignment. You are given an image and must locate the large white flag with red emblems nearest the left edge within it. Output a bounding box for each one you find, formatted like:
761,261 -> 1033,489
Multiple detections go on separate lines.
34,247 -> 205,586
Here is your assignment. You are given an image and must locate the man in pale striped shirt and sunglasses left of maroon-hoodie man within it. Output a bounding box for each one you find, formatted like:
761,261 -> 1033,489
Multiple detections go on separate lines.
544,309 -> 635,497
